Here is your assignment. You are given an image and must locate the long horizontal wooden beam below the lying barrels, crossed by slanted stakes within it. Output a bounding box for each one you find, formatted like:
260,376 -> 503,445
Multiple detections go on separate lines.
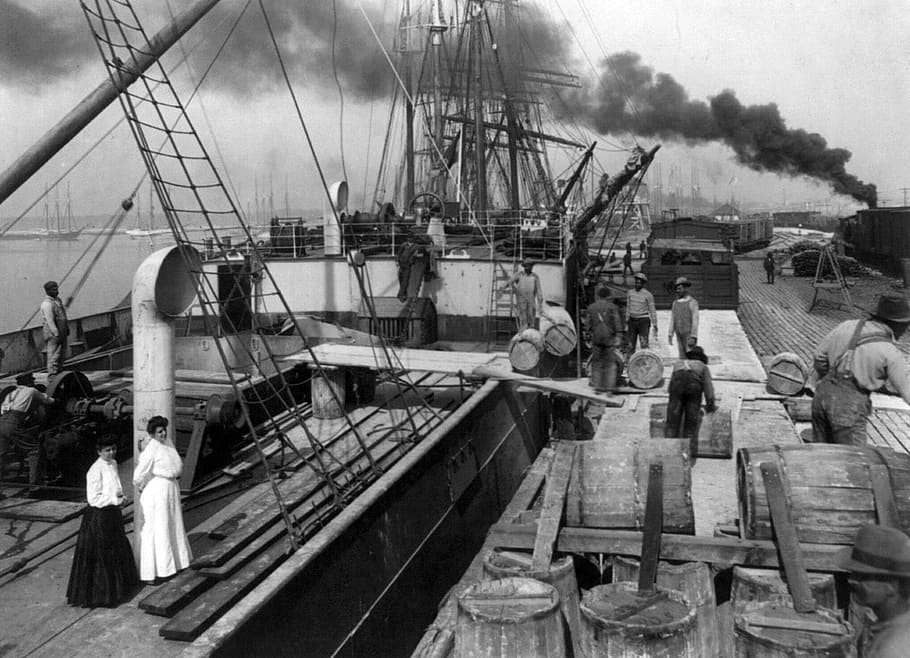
487,523 -> 844,573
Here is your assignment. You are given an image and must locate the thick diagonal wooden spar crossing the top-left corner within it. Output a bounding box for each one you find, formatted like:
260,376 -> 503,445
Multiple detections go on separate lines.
0,0 -> 219,203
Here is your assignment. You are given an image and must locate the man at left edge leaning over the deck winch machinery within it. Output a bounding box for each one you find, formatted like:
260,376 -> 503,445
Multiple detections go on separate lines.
0,372 -> 55,489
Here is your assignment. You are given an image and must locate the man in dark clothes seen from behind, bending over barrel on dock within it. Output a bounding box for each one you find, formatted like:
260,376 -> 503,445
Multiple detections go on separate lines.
664,345 -> 717,457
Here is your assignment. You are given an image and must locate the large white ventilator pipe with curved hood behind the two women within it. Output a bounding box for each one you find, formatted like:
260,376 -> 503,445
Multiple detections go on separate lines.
132,246 -> 201,457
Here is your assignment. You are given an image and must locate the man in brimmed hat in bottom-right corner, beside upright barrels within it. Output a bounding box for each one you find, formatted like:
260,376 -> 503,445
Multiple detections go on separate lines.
835,525 -> 910,658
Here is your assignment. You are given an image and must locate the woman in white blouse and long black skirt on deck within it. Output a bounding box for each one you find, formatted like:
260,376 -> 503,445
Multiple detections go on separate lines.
66,434 -> 139,608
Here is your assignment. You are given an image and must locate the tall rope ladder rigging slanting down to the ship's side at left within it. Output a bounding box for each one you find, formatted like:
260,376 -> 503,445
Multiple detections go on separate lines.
82,0 -> 381,550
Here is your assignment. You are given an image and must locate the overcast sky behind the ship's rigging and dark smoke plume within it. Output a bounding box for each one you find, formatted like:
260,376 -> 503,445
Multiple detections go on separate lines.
0,0 -> 910,223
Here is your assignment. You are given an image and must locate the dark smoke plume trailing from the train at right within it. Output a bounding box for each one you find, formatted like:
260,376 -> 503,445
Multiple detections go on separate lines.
564,52 -> 878,208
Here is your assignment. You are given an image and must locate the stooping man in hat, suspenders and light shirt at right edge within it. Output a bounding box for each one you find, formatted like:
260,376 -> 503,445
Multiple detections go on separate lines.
812,293 -> 910,446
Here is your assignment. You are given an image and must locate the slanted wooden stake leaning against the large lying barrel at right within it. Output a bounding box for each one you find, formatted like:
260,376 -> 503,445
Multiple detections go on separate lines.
759,462 -> 816,612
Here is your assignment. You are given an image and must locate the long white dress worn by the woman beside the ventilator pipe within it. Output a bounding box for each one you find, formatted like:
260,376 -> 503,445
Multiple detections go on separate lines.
133,439 -> 193,581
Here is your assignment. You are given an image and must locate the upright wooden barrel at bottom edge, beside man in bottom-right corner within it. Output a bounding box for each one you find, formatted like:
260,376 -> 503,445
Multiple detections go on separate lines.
733,602 -> 856,658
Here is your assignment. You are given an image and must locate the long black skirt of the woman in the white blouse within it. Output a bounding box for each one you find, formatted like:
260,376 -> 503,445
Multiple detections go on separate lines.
66,505 -> 139,608
